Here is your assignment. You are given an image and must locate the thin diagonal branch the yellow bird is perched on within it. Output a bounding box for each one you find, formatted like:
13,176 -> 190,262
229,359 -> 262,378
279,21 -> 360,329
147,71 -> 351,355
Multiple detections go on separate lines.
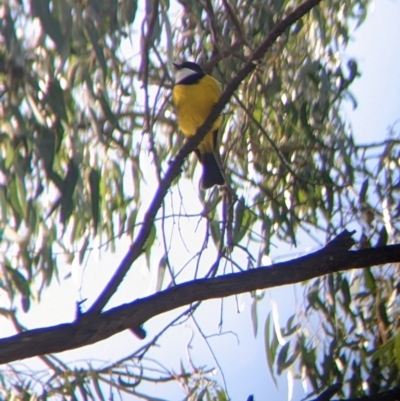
87,0 -> 321,315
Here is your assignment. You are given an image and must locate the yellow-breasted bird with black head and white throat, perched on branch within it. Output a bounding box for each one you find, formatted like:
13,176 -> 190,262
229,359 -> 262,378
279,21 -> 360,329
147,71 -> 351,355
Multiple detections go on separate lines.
172,61 -> 225,190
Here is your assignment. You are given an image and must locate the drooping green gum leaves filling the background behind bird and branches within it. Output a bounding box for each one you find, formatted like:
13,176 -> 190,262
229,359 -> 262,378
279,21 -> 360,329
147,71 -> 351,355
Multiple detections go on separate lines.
0,0 -> 400,399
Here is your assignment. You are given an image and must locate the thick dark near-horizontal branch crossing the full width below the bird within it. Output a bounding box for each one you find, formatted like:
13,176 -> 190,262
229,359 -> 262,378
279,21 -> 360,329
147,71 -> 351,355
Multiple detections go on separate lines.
0,231 -> 400,363
